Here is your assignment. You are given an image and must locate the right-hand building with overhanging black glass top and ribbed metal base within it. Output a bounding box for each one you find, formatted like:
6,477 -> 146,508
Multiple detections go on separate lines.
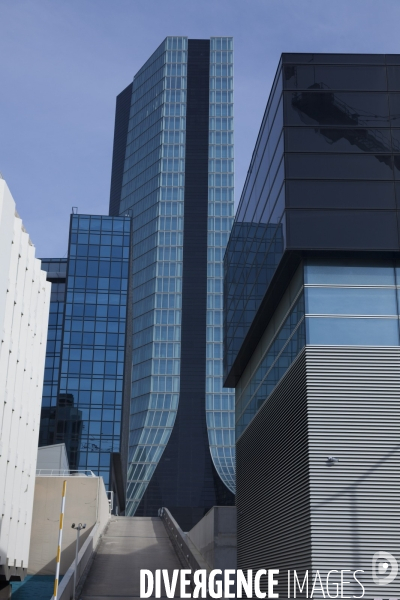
224,54 -> 400,597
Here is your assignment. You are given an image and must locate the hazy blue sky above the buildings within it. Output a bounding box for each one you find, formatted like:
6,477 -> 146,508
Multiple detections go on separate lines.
0,0 -> 400,257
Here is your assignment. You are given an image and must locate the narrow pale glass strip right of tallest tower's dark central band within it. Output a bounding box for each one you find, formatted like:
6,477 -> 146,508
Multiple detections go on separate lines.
206,38 -> 235,493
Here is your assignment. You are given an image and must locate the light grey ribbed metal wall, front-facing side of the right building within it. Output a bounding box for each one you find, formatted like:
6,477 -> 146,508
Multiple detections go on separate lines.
306,346 -> 400,598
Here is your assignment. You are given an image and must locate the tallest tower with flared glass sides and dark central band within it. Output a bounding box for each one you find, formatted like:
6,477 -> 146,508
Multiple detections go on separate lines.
110,37 -> 235,528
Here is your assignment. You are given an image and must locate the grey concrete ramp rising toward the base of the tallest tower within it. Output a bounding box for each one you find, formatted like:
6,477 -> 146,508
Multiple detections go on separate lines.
77,517 -> 182,600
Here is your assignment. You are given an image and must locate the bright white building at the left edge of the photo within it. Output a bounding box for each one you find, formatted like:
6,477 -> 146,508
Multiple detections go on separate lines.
0,176 -> 50,593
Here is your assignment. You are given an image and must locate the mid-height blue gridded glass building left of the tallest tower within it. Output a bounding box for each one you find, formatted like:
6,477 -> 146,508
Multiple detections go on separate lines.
40,214 -> 131,496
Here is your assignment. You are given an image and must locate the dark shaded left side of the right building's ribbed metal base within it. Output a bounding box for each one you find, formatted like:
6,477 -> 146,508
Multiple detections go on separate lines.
236,351 -> 311,598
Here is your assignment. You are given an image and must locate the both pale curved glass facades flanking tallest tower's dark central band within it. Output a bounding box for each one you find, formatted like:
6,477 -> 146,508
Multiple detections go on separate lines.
115,37 -> 235,515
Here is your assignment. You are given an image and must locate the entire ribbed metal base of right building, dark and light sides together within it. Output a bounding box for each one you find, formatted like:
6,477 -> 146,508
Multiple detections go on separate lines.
237,346 -> 400,599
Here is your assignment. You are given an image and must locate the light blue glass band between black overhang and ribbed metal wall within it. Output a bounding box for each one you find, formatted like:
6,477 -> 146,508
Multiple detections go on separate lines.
236,258 -> 400,438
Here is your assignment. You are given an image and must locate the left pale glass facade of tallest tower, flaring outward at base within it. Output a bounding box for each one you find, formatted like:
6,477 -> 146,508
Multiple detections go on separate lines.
121,37 -> 187,515
